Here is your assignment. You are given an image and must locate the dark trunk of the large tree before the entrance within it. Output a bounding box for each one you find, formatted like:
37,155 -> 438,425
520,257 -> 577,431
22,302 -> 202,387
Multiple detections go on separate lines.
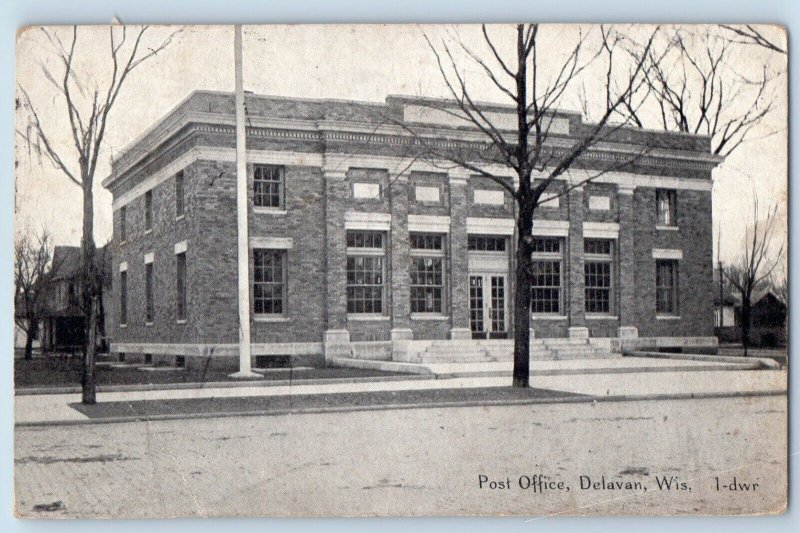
512,200 -> 533,387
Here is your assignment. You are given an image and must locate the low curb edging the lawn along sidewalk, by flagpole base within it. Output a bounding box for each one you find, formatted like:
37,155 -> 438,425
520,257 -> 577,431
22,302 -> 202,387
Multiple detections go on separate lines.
14,374 -> 436,396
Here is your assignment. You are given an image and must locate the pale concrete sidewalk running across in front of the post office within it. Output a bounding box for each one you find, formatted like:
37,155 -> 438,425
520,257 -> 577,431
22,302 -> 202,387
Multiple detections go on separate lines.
14,358 -> 787,425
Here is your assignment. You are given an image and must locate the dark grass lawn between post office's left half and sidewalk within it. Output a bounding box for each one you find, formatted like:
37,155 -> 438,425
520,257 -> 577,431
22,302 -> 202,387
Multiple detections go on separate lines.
14,356 -> 412,388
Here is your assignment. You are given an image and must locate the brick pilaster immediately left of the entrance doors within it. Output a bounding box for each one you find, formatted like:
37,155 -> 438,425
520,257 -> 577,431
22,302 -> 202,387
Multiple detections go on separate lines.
448,169 -> 472,339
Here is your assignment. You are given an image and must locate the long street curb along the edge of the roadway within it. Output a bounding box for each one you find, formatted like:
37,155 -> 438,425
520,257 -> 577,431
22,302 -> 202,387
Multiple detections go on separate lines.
14,390 -> 787,428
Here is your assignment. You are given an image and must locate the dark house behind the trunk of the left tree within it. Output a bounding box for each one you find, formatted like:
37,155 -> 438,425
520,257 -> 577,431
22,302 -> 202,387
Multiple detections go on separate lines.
40,246 -> 111,352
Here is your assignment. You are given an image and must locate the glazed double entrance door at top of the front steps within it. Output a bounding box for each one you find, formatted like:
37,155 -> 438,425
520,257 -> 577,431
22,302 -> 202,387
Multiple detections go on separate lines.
469,274 -> 508,339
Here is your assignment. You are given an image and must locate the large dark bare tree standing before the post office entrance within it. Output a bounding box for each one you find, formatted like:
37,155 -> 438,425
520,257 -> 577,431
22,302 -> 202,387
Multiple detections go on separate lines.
395,24 -> 658,387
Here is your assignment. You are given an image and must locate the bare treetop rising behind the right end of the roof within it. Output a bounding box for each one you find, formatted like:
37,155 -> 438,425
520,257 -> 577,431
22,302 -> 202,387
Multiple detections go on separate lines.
637,27 -> 775,156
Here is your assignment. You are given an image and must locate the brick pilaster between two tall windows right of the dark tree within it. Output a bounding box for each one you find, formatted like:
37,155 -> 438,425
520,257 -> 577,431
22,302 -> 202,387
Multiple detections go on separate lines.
566,187 -> 589,338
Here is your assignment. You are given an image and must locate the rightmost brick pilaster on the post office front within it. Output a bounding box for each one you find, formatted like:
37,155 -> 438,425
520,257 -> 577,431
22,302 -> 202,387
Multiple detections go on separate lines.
617,187 -> 639,339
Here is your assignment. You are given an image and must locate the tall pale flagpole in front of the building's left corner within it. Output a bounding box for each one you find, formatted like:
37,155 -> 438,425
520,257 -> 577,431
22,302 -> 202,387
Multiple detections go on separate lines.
231,24 -> 258,378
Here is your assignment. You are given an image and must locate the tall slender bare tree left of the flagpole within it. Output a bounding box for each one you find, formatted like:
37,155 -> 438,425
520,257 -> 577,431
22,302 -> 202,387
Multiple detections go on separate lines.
17,22 -> 180,404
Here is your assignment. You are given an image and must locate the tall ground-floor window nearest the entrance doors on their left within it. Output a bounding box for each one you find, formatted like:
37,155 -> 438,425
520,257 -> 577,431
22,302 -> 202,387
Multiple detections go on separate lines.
410,233 -> 444,313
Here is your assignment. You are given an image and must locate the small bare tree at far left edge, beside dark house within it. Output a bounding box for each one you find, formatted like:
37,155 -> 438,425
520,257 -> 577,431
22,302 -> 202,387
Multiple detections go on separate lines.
14,231 -> 53,359
